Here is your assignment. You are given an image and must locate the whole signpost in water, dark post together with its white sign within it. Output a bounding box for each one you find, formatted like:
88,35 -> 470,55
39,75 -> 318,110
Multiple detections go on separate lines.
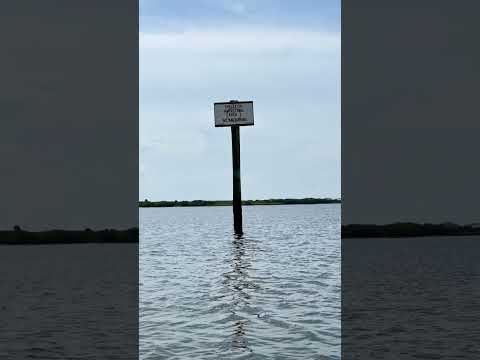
214,100 -> 253,235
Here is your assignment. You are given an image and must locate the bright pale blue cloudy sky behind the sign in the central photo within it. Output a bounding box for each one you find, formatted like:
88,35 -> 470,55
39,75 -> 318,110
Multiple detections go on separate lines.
139,0 -> 341,201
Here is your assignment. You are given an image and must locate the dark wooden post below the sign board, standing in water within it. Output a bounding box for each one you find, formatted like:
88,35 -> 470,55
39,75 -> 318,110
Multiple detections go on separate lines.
231,125 -> 243,235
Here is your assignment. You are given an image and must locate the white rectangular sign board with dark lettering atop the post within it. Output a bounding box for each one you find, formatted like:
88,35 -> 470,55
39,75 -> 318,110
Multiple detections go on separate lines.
213,101 -> 253,127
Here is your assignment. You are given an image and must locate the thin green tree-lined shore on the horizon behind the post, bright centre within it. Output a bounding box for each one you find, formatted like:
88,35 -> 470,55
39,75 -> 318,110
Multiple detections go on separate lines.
139,198 -> 341,207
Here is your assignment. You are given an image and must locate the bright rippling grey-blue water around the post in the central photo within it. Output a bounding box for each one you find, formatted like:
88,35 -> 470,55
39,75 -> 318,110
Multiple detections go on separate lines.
140,204 -> 340,360
